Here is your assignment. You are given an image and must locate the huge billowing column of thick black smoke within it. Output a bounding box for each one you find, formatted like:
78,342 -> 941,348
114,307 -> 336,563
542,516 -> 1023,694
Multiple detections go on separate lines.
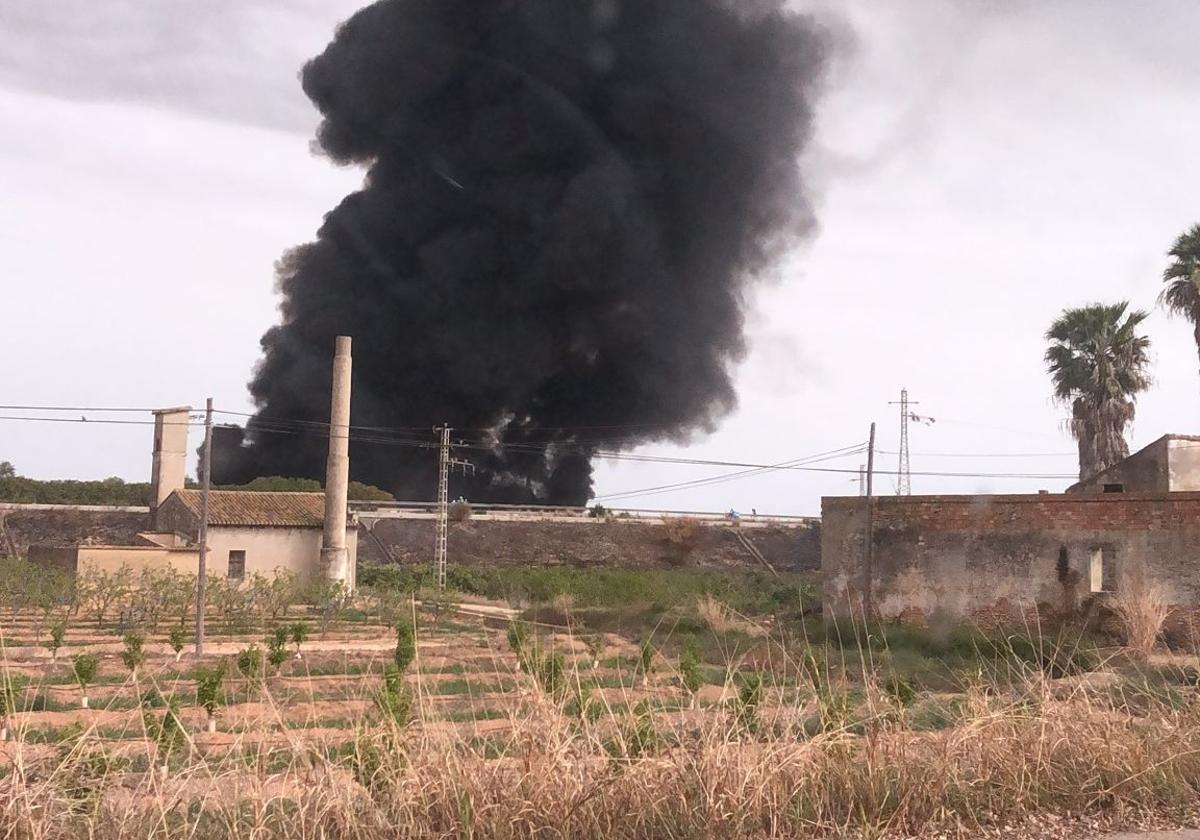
216,0 -> 826,504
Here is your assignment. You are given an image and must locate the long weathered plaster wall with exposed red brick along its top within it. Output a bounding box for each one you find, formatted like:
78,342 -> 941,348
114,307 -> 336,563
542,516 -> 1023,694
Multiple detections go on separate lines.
821,493 -> 1200,622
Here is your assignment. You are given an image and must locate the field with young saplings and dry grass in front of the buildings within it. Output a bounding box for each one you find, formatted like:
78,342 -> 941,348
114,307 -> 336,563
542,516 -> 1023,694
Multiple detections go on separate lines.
0,561 -> 1200,838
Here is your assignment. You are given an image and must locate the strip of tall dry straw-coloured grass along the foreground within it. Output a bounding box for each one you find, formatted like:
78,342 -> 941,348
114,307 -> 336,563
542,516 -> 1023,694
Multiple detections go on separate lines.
0,678 -> 1200,840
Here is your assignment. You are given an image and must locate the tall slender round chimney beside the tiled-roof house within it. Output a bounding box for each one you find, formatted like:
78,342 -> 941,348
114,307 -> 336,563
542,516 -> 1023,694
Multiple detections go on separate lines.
320,336 -> 350,581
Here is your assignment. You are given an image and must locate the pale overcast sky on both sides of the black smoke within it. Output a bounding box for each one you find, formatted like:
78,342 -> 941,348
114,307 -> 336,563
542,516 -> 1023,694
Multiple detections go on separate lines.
0,0 -> 1200,514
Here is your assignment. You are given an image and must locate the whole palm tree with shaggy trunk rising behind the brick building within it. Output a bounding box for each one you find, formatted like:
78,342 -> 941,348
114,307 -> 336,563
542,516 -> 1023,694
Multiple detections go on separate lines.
1045,301 -> 1150,479
